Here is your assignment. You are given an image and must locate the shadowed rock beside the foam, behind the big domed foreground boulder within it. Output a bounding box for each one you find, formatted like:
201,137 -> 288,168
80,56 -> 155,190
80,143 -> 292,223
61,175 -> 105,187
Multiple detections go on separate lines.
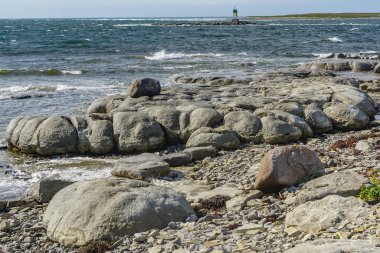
30,176 -> 74,203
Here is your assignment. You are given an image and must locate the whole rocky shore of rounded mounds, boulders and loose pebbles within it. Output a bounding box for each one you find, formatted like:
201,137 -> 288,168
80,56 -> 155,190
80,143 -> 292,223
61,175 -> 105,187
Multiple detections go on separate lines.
0,59 -> 380,253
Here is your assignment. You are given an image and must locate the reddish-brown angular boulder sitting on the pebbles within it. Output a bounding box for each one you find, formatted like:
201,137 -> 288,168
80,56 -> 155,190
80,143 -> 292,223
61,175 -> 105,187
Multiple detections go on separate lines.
255,145 -> 324,192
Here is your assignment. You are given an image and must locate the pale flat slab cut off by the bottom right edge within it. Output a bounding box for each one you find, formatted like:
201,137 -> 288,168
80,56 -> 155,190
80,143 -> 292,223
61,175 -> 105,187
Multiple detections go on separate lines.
285,239 -> 380,253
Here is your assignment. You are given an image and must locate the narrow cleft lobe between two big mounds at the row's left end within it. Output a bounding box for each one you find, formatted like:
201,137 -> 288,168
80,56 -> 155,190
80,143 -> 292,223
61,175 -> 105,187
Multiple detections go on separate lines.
71,117 -> 115,154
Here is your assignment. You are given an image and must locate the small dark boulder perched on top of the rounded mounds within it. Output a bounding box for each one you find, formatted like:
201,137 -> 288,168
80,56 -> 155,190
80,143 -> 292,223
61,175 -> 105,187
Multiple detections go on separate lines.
129,78 -> 161,98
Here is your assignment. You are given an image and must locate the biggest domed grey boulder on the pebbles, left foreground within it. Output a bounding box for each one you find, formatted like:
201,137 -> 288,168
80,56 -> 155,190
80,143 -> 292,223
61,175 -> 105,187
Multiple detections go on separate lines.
43,178 -> 194,246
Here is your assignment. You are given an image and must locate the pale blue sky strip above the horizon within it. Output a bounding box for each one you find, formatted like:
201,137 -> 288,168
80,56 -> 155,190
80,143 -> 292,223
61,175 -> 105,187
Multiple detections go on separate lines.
0,0 -> 380,18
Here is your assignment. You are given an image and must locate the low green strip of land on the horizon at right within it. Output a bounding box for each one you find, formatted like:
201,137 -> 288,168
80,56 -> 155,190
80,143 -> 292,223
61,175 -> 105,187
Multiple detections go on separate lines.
245,13 -> 380,20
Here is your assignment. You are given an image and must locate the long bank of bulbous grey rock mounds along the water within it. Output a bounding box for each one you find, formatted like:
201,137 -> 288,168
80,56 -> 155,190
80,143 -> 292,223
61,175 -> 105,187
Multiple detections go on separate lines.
6,70 -> 376,155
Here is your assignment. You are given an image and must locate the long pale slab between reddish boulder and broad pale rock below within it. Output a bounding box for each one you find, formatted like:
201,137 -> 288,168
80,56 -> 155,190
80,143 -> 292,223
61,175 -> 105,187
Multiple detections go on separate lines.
286,171 -> 369,205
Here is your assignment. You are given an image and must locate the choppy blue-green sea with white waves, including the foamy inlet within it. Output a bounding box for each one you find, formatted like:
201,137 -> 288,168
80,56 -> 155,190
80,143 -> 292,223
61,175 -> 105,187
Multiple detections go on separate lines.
0,18 -> 380,200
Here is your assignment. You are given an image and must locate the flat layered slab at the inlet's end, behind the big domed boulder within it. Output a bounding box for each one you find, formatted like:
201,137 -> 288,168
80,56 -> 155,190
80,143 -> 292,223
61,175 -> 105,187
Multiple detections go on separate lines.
112,153 -> 170,180
